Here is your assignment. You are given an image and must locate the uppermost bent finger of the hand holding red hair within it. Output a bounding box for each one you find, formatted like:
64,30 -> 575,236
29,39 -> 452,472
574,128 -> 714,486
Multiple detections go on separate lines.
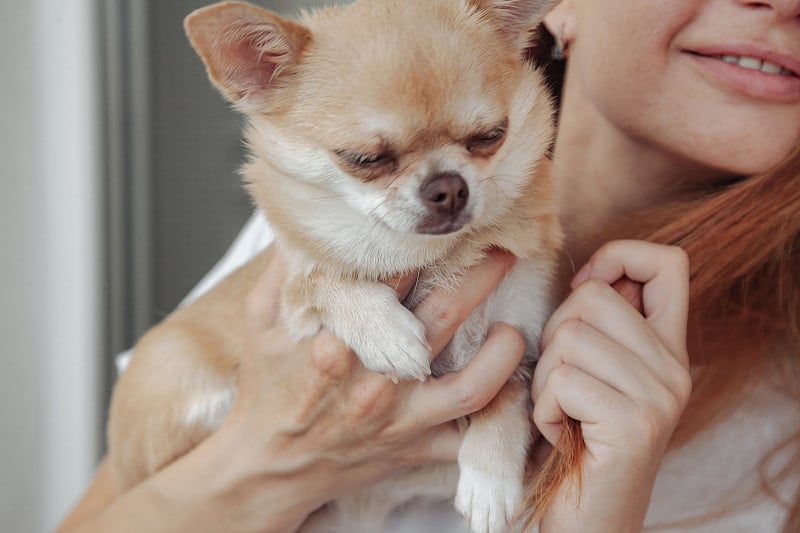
573,241 -> 689,365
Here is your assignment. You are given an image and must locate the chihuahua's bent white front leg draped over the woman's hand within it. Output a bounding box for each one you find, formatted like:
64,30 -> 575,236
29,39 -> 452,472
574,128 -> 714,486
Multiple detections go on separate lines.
282,273 -> 430,380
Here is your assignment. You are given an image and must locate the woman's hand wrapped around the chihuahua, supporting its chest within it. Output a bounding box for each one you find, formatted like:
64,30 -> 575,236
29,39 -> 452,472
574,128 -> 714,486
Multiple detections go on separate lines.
175,247 -> 523,531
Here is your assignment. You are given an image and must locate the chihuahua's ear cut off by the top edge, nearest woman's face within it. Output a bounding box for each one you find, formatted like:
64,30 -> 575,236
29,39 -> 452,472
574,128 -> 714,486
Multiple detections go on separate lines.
470,0 -> 560,50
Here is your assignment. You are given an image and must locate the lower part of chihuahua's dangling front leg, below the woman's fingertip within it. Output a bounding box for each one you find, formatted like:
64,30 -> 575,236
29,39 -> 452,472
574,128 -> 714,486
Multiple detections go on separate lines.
456,378 -> 532,533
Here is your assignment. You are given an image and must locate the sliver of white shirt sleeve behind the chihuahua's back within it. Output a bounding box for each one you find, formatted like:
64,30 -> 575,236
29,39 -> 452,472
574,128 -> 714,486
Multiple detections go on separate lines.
114,211 -> 275,374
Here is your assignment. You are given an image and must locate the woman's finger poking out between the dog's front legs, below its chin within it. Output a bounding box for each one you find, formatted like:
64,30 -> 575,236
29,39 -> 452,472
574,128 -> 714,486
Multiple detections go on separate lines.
414,250 -> 516,356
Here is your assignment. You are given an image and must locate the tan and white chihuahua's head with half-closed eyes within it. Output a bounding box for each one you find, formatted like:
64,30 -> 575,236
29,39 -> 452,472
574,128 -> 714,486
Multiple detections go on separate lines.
186,0 -> 557,260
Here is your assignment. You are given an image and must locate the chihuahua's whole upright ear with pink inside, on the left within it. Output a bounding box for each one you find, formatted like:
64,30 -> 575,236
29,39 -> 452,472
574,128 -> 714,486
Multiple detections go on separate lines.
184,2 -> 311,113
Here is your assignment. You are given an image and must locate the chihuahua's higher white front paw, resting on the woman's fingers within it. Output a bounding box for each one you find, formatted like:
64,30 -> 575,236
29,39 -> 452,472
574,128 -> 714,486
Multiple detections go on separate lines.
351,309 -> 431,381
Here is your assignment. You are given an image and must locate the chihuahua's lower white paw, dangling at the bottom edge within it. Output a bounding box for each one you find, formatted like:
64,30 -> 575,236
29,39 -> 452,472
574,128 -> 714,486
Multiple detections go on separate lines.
455,465 -> 522,533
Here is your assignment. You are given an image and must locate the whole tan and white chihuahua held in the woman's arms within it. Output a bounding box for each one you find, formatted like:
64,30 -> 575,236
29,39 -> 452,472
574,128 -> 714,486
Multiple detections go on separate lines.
109,0 -> 561,533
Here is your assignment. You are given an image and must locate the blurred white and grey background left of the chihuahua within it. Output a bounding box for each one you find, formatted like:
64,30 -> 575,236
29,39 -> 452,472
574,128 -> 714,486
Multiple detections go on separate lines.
0,0 -> 334,533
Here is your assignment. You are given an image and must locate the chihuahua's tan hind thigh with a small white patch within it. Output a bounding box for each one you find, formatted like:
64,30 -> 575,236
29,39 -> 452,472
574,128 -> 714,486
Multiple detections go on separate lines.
108,324 -> 235,489
